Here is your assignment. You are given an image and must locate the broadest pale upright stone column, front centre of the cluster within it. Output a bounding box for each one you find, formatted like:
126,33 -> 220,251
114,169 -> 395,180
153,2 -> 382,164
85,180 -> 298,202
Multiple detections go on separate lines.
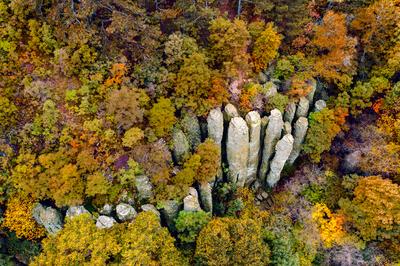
226,117 -> 249,187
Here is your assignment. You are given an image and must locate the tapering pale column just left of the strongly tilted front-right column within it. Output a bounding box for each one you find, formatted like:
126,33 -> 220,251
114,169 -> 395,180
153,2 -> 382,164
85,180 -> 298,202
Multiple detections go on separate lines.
259,109 -> 283,184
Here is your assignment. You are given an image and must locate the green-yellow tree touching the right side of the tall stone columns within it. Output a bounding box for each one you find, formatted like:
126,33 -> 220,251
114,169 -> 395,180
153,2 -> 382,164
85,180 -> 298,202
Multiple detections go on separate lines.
303,108 -> 341,162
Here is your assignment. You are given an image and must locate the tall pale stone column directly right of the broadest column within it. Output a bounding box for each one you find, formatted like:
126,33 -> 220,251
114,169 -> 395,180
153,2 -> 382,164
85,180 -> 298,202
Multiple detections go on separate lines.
246,111 -> 261,184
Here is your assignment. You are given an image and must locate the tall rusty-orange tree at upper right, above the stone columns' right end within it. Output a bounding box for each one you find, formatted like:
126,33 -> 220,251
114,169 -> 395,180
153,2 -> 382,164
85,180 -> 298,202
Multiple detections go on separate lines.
312,11 -> 356,87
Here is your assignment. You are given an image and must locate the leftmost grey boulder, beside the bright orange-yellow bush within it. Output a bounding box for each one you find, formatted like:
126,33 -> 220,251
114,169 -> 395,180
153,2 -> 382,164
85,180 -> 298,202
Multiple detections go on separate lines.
32,203 -> 62,235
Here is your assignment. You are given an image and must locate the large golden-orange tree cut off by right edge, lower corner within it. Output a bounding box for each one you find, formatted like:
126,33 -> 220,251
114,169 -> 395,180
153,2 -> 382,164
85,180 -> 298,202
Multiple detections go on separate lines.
339,176 -> 400,241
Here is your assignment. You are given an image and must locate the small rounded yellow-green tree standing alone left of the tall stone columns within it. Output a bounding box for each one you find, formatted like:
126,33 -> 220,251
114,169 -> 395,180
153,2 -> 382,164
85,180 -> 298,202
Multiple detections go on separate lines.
149,98 -> 177,137
